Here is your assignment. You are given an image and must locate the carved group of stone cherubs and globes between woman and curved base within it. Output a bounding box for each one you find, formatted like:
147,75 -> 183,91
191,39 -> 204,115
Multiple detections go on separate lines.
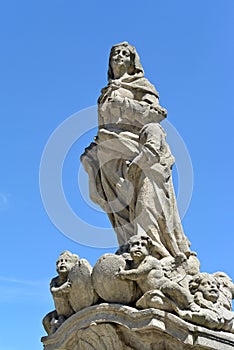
43,241 -> 234,336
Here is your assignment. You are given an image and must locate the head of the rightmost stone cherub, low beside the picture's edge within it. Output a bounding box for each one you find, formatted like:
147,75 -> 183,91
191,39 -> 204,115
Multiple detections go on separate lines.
189,272 -> 220,303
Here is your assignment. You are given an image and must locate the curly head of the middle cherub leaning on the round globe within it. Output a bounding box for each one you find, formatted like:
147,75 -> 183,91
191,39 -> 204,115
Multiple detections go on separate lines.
128,235 -> 152,260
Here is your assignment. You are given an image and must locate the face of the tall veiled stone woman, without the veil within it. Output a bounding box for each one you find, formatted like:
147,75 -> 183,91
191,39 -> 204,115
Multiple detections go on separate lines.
110,46 -> 131,77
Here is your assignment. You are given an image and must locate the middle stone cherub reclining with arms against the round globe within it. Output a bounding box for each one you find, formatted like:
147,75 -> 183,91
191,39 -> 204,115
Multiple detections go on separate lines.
117,235 -> 198,312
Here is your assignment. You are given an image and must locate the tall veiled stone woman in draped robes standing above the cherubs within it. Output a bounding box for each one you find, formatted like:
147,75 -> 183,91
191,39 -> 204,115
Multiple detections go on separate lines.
81,42 -> 190,258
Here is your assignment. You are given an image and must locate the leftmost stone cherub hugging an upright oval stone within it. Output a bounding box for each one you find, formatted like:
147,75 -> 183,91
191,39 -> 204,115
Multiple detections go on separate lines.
43,251 -> 98,334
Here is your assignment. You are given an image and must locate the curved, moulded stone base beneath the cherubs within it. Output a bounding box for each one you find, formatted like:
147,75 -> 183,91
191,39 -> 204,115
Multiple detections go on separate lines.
42,303 -> 234,350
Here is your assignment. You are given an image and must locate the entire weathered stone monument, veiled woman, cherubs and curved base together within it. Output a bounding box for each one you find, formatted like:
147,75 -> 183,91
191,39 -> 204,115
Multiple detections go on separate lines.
42,42 -> 234,350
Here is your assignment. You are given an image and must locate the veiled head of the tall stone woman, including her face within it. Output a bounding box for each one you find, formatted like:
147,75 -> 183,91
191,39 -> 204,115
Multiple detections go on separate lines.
108,41 -> 144,81
